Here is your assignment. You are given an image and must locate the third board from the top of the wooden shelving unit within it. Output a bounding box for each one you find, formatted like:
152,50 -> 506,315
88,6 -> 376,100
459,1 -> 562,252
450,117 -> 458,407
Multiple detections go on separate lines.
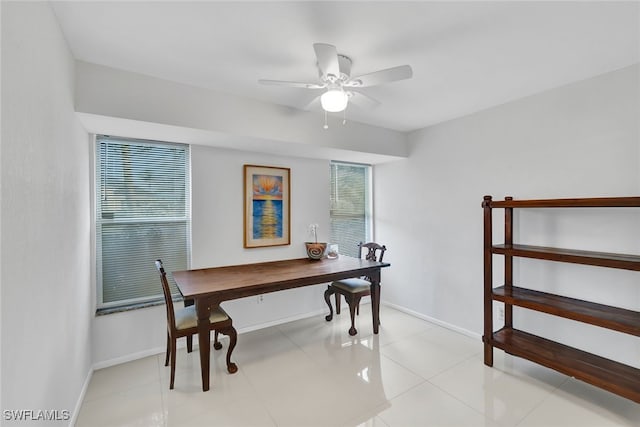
493,286 -> 640,336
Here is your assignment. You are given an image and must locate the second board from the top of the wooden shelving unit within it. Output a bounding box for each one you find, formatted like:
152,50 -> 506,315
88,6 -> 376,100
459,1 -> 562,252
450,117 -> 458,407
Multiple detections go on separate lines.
491,245 -> 640,271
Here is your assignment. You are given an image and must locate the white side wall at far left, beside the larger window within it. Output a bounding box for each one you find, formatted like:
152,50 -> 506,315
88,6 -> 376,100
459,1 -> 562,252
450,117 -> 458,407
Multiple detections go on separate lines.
1,2 -> 94,424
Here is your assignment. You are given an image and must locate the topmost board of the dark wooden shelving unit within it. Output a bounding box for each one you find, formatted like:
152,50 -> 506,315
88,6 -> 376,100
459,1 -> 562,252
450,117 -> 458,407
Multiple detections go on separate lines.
490,197 -> 640,208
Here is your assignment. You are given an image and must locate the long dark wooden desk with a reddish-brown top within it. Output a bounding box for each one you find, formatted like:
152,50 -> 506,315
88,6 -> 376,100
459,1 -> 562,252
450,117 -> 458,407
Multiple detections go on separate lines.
173,255 -> 390,391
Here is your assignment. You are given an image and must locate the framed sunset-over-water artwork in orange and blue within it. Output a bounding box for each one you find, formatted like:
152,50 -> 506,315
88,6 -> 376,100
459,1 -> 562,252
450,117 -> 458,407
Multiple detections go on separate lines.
244,165 -> 291,248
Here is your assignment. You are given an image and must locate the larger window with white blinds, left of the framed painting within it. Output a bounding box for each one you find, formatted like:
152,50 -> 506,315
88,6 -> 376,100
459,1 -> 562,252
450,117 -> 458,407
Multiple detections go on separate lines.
95,135 -> 190,308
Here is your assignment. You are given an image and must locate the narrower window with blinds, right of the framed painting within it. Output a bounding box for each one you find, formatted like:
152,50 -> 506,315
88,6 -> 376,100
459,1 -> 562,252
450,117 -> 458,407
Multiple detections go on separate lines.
331,162 -> 372,257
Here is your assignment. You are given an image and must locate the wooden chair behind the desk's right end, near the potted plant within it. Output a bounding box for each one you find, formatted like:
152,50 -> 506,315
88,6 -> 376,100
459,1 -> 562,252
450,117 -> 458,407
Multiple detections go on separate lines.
324,242 -> 387,335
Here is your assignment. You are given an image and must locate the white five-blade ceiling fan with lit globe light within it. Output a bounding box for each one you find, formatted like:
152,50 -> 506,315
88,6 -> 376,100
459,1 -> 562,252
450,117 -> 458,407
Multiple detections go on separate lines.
258,43 -> 413,115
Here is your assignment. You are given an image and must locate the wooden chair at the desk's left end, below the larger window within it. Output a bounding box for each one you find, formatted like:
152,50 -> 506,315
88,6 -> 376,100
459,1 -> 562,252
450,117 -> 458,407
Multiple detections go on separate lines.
156,260 -> 238,390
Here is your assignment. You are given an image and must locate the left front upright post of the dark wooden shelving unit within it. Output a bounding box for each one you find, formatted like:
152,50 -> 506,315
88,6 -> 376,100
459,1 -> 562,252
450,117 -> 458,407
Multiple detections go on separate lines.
482,196 -> 493,366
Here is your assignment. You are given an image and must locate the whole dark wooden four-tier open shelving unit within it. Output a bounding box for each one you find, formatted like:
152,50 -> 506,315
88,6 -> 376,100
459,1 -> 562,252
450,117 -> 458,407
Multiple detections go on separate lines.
482,196 -> 640,403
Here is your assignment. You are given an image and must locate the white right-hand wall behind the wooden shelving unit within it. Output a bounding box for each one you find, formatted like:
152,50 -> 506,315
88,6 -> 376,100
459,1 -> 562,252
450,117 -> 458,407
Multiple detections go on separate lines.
375,65 -> 640,366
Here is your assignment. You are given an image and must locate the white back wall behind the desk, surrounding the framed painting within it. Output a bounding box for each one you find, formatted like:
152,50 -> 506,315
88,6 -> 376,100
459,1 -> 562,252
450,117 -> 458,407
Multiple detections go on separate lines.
93,145 -> 329,367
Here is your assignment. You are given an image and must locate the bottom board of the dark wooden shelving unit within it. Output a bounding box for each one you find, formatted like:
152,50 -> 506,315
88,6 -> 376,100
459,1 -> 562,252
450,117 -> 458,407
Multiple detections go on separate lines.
490,328 -> 640,403
